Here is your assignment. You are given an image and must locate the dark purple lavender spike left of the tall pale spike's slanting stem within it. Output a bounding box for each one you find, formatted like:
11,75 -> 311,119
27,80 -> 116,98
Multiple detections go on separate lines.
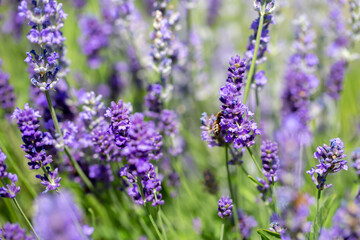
11,103 -> 52,169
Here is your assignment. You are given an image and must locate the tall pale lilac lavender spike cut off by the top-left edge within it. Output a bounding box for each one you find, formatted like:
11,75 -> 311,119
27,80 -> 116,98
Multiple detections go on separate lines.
18,0 -> 67,91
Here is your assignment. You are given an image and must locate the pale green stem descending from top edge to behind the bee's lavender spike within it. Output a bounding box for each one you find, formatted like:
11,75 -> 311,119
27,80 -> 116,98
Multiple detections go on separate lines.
243,1 -> 266,104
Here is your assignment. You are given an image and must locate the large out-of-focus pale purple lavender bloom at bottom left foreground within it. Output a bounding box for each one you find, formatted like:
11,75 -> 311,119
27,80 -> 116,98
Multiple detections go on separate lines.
34,191 -> 93,240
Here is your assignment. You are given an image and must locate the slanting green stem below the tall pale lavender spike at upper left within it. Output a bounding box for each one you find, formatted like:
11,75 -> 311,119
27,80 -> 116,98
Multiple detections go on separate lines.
45,91 -> 95,192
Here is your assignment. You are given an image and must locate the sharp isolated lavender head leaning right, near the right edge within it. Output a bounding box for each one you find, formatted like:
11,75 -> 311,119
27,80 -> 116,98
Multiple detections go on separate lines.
306,138 -> 348,190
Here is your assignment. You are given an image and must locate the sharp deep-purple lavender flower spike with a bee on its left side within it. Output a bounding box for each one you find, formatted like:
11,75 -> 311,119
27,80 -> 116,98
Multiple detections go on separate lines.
201,55 -> 260,149
